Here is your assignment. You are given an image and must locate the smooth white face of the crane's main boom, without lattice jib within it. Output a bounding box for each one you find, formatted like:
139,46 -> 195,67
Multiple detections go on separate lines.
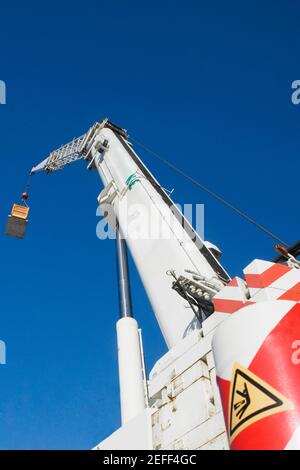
91,128 -> 229,348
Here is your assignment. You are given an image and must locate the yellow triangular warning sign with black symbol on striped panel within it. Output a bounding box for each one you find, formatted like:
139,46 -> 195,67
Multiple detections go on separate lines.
228,363 -> 293,441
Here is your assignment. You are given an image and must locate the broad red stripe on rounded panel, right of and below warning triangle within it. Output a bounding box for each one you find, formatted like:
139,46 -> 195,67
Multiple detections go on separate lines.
232,304 -> 300,450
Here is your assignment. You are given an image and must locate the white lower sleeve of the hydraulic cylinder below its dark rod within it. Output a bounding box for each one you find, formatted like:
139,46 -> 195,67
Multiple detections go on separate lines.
117,317 -> 145,425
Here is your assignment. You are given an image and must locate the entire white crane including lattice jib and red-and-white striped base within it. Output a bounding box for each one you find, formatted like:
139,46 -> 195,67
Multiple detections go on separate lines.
8,119 -> 300,449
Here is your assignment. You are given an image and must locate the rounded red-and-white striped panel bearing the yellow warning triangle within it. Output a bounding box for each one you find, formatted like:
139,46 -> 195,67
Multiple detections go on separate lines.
212,300 -> 300,449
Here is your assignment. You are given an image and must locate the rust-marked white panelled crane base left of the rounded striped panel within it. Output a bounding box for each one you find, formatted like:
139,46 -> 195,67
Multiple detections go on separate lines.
95,320 -> 229,450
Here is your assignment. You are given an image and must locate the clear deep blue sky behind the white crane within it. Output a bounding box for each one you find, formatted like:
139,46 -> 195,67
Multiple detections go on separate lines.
0,0 -> 300,449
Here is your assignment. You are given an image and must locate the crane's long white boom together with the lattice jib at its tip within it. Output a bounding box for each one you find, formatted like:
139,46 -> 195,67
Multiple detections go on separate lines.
32,119 -> 230,348
